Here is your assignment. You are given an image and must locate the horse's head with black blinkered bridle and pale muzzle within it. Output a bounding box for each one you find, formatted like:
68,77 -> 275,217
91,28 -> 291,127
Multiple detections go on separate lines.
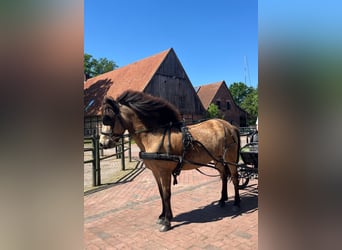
100,94 -> 125,148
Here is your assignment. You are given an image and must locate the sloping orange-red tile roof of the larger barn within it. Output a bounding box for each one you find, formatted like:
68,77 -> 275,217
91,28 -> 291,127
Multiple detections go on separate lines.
84,48 -> 172,116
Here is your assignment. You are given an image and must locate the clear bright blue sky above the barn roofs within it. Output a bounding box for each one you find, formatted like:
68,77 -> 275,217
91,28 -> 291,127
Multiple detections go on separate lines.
84,0 -> 258,87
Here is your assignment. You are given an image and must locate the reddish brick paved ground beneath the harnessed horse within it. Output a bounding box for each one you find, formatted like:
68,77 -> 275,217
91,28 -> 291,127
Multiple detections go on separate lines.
84,140 -> 258,250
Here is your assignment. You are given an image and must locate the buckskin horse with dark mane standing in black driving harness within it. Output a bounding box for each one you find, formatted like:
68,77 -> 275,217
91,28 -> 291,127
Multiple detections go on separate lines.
100,90 -> 240,232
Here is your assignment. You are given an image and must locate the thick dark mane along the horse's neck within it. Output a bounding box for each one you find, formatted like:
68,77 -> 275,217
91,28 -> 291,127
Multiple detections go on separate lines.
116,90 -> 181,128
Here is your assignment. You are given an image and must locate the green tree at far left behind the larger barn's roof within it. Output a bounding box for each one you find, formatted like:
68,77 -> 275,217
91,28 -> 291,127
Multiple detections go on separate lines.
83,53 -> 118,79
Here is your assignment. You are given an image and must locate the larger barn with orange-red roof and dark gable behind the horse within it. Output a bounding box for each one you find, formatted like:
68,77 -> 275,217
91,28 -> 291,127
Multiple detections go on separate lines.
84,48 -> 206,135
